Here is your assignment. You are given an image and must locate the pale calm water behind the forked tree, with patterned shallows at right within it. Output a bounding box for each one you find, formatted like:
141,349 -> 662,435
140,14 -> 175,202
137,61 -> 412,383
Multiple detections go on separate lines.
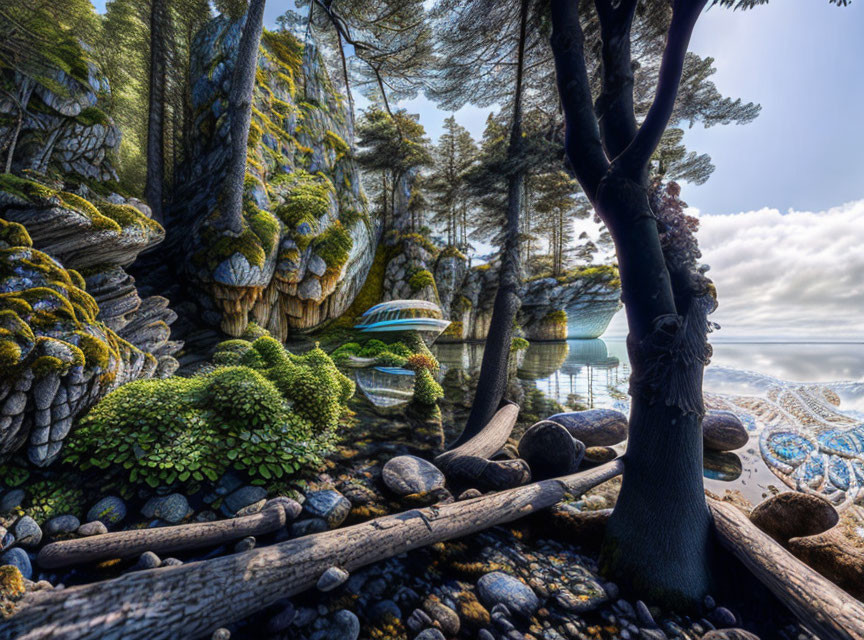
435,339 -> 864,509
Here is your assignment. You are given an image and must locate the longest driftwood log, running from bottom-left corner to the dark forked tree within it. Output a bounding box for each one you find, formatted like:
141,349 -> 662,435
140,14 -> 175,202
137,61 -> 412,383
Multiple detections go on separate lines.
0,460 -> 624,640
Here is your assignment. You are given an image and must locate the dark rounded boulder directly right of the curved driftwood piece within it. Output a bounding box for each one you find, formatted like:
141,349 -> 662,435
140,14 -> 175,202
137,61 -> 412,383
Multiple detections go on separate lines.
519,420 -> 585,480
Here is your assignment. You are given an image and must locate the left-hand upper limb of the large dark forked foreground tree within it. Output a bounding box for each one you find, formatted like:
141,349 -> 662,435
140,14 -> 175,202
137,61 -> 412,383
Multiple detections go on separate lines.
550,0 -> 609,201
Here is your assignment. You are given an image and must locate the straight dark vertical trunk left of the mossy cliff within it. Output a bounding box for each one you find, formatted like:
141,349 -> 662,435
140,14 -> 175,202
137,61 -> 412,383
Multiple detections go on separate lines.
144,0 -> 167,222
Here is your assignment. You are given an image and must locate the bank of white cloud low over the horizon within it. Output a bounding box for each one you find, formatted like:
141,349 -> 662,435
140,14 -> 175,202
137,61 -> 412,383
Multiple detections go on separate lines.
607,200 -> 864,341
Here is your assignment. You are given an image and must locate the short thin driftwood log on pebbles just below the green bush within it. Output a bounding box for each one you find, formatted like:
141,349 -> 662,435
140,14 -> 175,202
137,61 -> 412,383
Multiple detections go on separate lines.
37,504 -> 287,569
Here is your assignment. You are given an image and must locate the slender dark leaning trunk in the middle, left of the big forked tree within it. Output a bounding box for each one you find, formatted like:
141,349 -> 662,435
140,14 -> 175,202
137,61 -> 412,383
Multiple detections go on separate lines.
453,0 -> 528,447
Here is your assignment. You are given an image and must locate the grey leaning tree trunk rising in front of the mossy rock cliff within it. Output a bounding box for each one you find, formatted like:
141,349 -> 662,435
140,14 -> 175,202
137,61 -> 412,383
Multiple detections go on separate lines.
221,0 -> 265,233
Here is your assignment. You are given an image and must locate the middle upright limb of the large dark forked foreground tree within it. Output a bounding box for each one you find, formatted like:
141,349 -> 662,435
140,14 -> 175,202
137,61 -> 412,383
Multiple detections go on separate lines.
594,0 -> 637,158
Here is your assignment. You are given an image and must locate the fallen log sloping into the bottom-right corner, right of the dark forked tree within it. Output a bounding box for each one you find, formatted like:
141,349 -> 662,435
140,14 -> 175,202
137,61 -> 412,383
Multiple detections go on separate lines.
708,499 -> 864,640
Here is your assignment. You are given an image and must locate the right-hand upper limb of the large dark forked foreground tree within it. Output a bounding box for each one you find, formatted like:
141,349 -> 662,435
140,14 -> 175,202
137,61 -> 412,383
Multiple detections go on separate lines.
616,0 -> 708,178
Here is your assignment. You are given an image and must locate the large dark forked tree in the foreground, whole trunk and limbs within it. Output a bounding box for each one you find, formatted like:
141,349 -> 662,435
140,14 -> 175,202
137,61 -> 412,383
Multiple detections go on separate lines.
550,0 -> 842,606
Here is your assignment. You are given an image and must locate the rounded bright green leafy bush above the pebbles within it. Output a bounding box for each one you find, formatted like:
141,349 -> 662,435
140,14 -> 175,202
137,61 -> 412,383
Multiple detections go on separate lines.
66,336 -> 354,487
